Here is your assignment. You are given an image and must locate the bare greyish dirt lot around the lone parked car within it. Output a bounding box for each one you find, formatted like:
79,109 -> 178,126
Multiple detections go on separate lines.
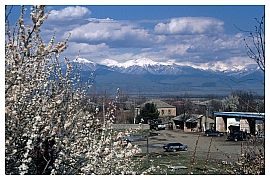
136,130 -> 241,161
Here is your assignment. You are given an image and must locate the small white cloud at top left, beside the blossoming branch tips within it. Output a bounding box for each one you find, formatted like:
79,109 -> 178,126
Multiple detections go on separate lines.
48,6 -> 91,21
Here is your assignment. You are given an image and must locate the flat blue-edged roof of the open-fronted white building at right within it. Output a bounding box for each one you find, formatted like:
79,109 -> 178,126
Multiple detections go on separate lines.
214,112 -> 264,119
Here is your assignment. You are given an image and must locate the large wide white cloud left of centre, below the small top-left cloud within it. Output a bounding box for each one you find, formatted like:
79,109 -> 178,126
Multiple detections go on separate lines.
65,19 -> 164,47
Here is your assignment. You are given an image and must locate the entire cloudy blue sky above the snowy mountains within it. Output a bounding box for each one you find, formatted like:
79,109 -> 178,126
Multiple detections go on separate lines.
6,5 -> 264,71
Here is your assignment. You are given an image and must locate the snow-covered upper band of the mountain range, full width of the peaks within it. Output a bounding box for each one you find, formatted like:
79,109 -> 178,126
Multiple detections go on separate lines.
73,58 -> 264,76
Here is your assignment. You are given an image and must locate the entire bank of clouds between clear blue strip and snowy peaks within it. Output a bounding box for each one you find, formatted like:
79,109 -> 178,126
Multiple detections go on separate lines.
43,6 -> 250,70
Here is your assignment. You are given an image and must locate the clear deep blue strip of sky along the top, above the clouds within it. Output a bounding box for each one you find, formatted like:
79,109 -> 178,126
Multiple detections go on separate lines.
85,5 -> 264,33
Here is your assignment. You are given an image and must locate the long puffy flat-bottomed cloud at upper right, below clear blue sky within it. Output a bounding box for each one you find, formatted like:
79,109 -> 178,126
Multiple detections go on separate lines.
155,17 -> 224,34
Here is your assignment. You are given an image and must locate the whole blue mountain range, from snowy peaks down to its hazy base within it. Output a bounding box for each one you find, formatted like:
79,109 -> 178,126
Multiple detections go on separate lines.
72,58 -> 264,96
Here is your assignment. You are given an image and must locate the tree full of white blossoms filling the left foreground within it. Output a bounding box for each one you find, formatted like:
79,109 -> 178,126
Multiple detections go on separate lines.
5,6 -> 140,174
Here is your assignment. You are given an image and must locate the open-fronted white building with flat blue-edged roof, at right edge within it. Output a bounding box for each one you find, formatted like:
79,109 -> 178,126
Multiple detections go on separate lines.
214,112 -> 265,135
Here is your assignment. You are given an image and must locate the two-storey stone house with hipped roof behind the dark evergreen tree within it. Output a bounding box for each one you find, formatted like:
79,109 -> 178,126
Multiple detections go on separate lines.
135,99 -> 176,119
